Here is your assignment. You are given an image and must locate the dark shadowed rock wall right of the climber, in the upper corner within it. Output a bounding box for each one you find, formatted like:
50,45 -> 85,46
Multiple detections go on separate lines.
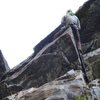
76,0 -> 100,45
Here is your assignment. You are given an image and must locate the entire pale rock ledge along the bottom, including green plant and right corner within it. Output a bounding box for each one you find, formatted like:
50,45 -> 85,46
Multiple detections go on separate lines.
3,70 -> 100,100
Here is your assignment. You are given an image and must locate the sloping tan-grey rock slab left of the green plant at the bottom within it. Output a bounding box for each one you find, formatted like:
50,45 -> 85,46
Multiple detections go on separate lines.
2,70 -> 90,100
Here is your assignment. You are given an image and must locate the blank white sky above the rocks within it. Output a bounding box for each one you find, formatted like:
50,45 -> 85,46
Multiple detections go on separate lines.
0,0 -> 87,68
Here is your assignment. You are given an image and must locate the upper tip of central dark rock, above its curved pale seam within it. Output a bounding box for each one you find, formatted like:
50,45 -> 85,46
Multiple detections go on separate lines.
34,28 -> 77,62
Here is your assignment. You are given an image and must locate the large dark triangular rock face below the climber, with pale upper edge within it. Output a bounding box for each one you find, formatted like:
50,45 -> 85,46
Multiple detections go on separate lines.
0,28 -> 77,98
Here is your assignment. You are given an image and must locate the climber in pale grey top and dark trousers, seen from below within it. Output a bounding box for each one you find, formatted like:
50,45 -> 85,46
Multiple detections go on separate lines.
61,10 -> 82,51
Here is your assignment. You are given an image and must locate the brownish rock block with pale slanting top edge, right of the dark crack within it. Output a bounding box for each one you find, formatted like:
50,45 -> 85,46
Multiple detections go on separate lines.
84,48 -> 100,80
